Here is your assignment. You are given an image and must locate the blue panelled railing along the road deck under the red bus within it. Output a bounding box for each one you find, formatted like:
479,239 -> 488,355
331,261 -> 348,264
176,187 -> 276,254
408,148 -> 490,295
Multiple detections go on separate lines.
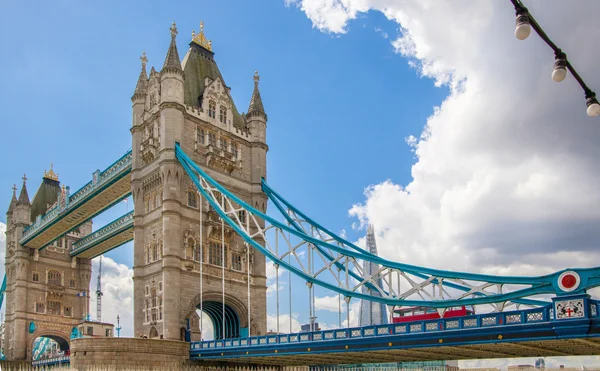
191,300 -> 600,352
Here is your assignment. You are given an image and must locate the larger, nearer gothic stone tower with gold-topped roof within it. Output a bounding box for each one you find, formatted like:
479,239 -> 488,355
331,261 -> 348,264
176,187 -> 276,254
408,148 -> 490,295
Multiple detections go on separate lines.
131,23 -> 268,340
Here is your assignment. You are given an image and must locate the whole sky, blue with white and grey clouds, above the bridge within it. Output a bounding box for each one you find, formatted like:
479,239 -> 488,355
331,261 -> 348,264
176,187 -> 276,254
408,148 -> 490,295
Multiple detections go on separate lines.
0,0 -> 600,368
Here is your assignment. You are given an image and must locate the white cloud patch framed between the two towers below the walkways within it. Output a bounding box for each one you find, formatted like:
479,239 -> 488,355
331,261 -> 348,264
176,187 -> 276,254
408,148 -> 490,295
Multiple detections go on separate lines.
90,257 -> 133,336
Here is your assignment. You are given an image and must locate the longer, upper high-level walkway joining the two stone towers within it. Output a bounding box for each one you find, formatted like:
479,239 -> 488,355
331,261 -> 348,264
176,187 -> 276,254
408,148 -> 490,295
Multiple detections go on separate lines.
19,151 -> 132,249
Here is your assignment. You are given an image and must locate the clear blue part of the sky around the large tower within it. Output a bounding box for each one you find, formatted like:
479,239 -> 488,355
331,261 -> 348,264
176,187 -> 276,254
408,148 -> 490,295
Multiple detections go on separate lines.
0,1 -> 447,334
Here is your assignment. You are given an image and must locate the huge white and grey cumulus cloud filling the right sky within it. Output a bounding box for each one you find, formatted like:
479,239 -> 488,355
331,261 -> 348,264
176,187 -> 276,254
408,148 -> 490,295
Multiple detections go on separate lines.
287,0 -> 600,366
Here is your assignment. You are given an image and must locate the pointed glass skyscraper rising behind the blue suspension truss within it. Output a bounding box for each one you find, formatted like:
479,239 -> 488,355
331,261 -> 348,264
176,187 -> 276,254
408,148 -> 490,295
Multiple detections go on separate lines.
358,225 -> 388,326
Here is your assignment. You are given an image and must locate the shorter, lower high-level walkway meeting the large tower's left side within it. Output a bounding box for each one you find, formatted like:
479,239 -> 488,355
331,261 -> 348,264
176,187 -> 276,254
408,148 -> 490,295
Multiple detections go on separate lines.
70,211 -> 133,259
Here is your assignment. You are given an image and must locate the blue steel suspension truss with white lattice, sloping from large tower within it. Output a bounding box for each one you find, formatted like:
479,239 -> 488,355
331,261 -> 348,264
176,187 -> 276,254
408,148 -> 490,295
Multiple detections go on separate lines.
175,144 -> 600,313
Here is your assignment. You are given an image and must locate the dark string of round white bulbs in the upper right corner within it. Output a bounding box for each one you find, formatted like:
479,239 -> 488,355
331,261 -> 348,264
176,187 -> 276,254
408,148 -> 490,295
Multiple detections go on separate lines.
510,0 -> 600,117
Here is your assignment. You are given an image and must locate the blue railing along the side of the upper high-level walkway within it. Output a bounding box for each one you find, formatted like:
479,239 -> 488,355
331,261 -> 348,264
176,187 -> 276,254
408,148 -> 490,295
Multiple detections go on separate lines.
20,151 -> 133,244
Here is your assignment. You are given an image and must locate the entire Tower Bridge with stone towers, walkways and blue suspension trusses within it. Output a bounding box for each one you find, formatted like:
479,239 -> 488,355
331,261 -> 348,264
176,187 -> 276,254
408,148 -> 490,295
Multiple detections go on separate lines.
0,20 -> 600,364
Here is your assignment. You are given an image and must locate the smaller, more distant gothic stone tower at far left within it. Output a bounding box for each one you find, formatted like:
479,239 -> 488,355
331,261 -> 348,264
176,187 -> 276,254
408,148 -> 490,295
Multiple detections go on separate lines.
2,167 -> 92,360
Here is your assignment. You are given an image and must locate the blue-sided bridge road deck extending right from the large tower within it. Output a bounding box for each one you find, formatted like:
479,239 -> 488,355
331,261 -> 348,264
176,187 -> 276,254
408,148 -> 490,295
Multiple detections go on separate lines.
190,306 -> 600,365
